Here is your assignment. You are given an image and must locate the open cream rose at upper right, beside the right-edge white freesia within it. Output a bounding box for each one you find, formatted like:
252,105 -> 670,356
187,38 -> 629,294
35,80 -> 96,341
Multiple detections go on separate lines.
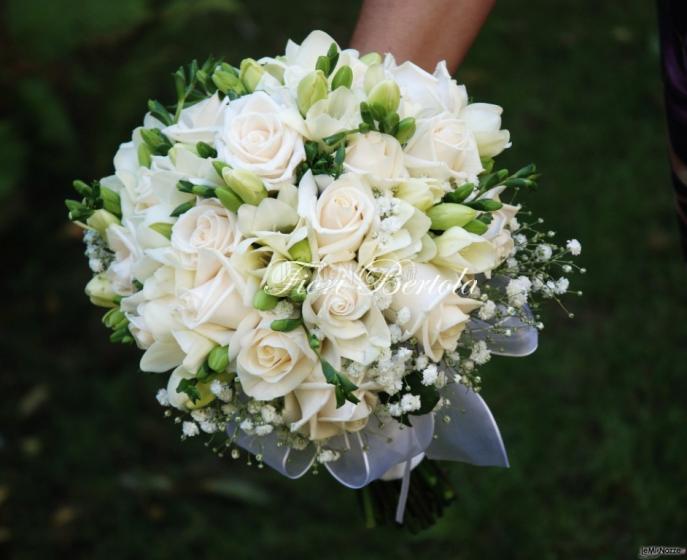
405,113 -> 483,182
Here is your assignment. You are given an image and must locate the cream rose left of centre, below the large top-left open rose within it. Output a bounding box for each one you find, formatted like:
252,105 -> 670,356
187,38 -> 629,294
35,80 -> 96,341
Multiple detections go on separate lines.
171,200 -> 241,270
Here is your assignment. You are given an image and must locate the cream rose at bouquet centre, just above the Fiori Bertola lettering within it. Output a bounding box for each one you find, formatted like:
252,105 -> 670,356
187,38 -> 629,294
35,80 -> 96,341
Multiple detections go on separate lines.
298,171 -> 376,262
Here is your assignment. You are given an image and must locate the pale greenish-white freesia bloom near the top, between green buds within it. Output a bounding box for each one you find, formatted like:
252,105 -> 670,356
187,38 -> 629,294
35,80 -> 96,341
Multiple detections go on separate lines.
305,87 -> 361,140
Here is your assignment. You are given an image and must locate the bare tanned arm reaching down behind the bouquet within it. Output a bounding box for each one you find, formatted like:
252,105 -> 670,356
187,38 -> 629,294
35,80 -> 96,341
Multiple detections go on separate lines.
351,0 -> 496,73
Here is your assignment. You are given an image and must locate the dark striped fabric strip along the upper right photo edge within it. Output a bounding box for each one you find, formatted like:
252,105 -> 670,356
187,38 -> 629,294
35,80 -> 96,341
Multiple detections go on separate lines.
658,0 -> 687,260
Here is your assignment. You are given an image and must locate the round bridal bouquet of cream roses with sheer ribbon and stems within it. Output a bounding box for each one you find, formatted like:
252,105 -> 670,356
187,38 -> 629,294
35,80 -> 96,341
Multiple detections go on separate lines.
67,31 -> 583,530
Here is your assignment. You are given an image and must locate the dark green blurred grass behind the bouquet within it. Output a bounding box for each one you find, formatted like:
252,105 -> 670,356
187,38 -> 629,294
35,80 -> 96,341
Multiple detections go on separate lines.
0,0 -> 687,559
